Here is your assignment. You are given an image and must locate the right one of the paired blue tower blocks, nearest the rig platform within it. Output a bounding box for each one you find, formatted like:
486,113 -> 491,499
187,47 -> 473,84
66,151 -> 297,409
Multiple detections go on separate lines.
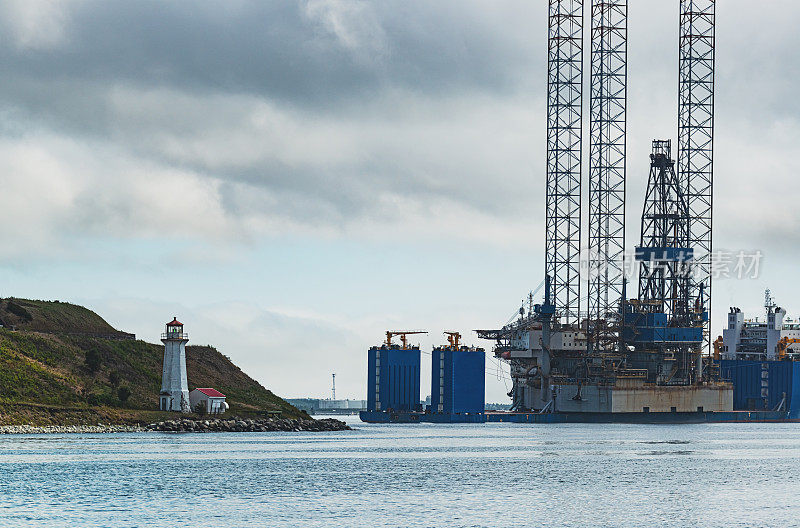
430,347 -> 486,415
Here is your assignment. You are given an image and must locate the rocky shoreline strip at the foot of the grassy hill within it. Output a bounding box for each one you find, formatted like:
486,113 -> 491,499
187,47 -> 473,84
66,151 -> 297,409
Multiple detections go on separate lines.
0,417 -> 351,434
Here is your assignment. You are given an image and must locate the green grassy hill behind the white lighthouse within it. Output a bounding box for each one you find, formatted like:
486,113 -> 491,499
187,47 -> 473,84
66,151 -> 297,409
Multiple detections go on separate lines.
0,299 -> 303,424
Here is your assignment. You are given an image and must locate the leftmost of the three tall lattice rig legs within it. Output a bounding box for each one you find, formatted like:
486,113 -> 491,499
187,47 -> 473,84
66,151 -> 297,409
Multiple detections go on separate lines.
545,0 -> 583,323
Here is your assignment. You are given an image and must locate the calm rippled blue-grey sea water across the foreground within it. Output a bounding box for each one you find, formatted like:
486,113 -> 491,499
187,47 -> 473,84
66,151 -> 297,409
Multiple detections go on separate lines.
0,421 -> 800,528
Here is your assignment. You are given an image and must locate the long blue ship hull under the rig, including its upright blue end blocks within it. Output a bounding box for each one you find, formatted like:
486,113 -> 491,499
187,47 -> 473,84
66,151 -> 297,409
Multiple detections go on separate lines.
360,338 -> 800,424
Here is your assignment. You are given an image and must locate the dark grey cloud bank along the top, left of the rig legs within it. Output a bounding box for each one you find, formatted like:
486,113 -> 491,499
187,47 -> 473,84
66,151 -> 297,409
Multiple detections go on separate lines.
0,0 -> 544,107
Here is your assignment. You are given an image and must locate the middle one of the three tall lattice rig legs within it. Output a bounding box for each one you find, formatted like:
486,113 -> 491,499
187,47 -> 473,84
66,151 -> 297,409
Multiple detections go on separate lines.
588,0 -> 628,330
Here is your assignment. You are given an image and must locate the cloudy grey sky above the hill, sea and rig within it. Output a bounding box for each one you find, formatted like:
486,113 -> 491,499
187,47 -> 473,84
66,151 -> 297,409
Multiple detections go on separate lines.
0,0 -> 800,401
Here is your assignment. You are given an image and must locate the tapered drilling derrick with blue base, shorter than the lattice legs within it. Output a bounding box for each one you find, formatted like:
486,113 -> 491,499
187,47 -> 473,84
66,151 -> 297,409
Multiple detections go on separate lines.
623,140 -> 708,385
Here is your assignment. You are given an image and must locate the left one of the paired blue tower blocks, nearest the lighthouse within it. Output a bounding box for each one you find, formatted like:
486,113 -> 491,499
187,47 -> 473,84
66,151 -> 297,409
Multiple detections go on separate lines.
367,346 -> 421,411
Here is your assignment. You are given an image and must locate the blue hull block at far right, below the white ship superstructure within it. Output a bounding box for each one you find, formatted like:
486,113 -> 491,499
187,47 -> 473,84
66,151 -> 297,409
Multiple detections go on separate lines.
720,359 -> 800,419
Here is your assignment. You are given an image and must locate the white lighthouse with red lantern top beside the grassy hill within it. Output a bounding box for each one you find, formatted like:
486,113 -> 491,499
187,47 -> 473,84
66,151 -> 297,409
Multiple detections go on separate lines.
159,318 -> 191,412
